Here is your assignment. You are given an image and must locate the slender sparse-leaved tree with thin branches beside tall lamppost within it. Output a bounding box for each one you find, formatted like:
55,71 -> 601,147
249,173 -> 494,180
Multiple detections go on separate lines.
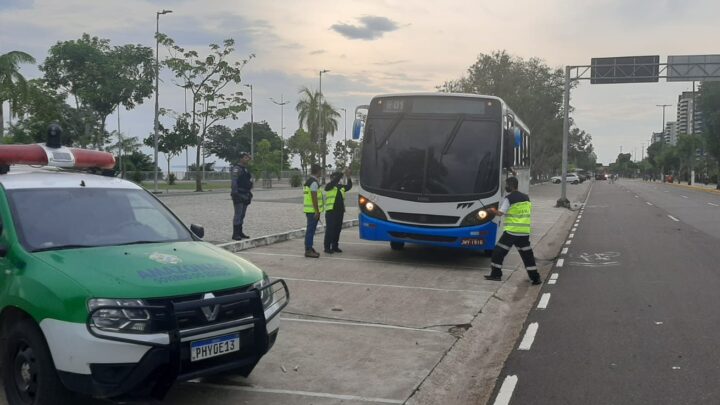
158,34 -> 254,191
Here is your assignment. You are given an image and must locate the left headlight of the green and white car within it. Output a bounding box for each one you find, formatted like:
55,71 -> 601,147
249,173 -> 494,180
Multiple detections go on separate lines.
88,298 -> 151,333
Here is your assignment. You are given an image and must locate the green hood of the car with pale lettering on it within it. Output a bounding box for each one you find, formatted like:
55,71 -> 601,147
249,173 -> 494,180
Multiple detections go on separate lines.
35,242 -> 263,298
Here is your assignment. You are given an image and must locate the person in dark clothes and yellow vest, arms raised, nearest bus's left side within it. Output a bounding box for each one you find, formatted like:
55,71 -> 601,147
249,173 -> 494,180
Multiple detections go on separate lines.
324,169 -> 352,254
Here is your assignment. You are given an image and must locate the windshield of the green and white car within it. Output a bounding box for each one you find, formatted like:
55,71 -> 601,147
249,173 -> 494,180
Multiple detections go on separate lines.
7,188 -> 192,252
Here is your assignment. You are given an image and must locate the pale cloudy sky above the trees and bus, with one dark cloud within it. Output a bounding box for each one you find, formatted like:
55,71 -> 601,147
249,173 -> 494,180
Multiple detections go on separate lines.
0,0 -> 720,165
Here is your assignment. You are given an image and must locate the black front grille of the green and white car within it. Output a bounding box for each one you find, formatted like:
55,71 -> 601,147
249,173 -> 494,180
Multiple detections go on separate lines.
145,286 -> 252,330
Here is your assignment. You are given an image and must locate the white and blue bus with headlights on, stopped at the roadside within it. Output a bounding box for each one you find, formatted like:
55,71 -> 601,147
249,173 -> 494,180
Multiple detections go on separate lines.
353,93 -> 530,251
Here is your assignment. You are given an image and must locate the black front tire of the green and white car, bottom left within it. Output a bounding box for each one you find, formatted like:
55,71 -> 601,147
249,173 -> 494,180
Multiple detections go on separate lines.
2,319 -> 73,405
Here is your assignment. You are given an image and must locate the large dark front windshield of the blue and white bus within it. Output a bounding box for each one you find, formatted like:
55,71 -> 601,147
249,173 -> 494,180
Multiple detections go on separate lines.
360,98 -> 501,201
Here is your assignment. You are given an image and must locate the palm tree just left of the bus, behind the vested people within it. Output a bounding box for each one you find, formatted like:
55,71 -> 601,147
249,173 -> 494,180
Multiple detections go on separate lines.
295,87 -> 340,172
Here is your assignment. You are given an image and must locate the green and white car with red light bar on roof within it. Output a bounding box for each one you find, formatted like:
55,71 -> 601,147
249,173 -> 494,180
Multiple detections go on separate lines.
0,140 -> 289,405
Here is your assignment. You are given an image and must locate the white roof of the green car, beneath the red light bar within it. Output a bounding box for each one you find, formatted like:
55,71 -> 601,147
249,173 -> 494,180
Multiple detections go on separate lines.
0,165 -> 142,190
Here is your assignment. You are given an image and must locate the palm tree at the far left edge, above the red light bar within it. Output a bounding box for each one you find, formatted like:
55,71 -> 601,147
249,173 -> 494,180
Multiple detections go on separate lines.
0,51 -> 35,137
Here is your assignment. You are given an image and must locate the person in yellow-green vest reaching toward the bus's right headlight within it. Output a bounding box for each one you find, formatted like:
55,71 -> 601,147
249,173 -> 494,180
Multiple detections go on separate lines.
485,177 -> 542,285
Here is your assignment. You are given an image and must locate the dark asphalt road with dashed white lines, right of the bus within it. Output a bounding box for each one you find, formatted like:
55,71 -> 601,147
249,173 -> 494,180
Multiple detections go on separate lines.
489,181 -> 720,405
